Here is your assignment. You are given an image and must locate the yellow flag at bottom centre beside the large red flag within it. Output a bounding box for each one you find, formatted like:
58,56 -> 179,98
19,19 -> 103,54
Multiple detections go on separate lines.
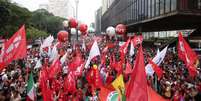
112,74 -> 125,96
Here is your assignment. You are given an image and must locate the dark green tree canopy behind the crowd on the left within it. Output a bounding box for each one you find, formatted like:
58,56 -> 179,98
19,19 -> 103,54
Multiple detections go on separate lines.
0,0 -> 64,39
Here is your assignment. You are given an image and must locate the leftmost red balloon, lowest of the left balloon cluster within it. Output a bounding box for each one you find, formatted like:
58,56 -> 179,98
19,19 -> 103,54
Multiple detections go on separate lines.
57,31 -> 68,42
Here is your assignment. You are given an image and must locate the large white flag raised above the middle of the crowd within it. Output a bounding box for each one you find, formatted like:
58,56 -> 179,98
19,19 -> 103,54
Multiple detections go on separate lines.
84,41 -> 100,68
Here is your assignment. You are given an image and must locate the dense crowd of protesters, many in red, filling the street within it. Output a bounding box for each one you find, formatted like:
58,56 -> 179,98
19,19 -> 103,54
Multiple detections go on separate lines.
0,35 -> 201,101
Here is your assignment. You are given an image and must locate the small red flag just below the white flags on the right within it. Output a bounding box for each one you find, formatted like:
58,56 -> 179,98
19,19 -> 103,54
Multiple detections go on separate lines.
149,59 -> 163,79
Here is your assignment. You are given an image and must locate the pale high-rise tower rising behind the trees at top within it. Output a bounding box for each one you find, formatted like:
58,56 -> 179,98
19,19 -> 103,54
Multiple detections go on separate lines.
48,0 -> 76,18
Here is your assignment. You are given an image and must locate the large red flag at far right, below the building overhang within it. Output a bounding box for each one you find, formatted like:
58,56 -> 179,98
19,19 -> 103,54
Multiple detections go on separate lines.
177,32 -> 198,77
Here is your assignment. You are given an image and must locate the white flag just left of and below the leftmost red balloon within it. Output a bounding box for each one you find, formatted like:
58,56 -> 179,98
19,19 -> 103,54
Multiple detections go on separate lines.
41,35 -> 54,48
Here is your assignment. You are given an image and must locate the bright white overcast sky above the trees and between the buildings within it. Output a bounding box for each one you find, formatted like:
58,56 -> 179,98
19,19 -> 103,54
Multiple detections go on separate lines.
12,0 -> 101,24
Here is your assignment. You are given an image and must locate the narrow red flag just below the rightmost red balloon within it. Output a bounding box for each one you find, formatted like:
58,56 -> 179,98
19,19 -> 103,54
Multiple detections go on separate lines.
119,38 -> 130,63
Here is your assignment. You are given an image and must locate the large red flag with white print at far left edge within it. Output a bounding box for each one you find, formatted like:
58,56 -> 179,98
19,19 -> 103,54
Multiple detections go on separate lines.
0,25 -> 27,70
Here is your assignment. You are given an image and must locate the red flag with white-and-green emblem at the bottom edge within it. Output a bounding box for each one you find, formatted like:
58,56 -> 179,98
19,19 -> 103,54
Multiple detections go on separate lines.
98,87 -> 120,101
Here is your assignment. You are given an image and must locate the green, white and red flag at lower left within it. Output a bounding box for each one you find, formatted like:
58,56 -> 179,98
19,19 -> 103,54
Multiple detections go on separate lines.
26,72 -> 36,101
